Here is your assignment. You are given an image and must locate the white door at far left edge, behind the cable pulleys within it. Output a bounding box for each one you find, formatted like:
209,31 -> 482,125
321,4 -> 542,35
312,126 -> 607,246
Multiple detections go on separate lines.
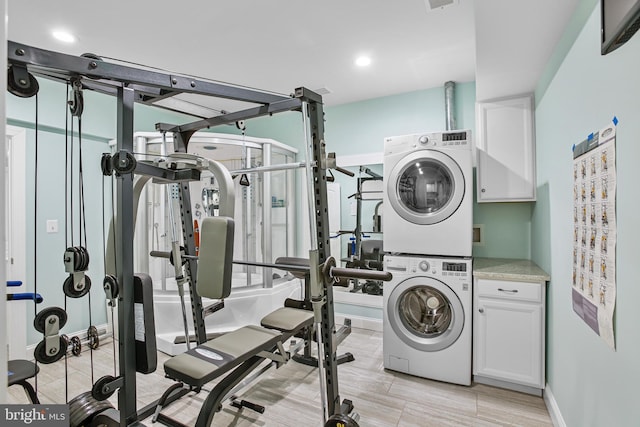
5,126 -> 27,359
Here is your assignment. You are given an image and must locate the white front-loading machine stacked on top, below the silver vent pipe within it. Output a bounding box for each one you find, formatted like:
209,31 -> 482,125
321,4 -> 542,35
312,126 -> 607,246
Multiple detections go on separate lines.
382,130 -> 473,256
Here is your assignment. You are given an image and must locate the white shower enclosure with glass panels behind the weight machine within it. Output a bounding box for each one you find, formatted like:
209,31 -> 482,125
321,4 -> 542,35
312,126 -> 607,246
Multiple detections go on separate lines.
134,132 -> 301,354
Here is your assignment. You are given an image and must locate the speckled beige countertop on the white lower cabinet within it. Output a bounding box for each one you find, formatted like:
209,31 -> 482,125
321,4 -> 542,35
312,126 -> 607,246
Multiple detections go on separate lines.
473,258 -> 550,282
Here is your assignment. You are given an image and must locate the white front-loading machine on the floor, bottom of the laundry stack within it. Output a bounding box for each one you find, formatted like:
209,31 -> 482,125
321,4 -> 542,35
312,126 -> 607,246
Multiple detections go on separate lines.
382,255 -> 472,385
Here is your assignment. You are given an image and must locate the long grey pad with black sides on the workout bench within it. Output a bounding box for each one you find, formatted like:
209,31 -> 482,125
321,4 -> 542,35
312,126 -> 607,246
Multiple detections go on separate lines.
164,325 -> 282,387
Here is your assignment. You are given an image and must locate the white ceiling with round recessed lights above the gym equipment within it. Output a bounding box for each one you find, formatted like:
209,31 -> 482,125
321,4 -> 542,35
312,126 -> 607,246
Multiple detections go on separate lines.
8,0 -> 578,113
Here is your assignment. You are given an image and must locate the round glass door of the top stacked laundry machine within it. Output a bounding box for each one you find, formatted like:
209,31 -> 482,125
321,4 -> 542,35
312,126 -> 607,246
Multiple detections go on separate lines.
387,150 -> 465,225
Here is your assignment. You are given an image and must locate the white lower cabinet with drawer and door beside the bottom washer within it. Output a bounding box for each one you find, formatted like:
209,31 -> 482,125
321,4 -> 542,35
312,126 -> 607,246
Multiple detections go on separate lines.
473,279 -> 545,394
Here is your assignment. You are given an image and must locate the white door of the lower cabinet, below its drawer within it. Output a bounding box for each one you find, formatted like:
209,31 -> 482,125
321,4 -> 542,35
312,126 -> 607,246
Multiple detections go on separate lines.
474,298 -> 544,388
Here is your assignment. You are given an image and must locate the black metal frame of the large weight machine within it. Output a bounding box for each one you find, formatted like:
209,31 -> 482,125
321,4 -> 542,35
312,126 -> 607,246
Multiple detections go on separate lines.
8,41 -> 341,425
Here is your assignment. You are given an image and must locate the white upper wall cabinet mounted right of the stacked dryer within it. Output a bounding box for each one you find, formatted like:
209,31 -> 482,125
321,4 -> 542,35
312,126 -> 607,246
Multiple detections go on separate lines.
476,95 -> 536,202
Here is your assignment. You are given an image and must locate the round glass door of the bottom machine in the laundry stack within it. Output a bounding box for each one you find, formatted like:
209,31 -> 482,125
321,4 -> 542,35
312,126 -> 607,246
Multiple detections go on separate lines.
385,277 -> 464,351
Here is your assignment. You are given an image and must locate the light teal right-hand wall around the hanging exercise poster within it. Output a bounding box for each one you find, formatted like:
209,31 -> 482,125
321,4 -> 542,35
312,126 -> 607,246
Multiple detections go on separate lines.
532,0 -> 640,427
